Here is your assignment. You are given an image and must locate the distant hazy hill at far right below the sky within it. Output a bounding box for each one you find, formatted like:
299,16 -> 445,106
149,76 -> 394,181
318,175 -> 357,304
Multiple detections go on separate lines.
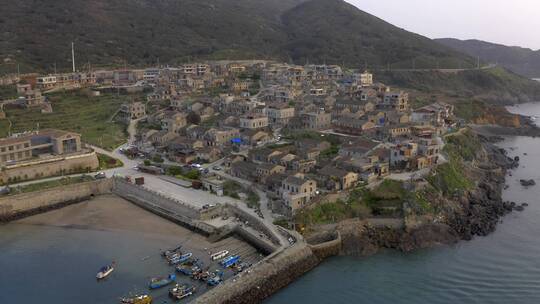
436,38 -> 540,78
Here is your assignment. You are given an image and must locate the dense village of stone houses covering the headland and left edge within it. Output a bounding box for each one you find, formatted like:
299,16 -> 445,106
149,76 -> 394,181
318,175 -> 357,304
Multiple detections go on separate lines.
0,61 -> 459,218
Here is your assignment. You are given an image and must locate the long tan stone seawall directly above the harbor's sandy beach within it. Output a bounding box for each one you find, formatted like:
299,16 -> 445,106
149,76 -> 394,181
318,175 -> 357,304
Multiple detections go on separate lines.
0,179 -> 112,222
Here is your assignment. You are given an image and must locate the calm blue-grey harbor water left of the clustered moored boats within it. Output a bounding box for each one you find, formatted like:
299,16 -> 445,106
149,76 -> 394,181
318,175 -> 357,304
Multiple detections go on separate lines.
0,224 -> 182,304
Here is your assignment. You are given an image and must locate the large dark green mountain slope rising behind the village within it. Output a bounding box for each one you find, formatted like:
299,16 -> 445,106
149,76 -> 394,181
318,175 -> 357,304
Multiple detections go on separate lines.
0,0 -> 474,72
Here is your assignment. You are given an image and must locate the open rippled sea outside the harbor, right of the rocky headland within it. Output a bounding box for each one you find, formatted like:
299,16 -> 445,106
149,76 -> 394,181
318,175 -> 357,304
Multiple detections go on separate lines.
266,104 -> 540,304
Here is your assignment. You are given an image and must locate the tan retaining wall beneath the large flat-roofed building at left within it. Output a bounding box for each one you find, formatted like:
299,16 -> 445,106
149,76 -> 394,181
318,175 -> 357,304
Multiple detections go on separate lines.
0,152 -> 99,184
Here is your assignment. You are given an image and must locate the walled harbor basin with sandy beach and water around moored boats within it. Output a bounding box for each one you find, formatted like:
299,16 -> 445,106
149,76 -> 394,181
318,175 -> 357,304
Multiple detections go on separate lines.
0,194 -> 264,303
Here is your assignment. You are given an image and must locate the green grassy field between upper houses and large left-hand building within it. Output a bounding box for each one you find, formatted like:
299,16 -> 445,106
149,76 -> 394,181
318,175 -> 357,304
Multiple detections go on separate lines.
5,91 -> 132,150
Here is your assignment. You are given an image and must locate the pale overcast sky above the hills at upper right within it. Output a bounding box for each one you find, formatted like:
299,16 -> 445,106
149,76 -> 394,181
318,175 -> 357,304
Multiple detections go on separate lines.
346,0 -> 540,50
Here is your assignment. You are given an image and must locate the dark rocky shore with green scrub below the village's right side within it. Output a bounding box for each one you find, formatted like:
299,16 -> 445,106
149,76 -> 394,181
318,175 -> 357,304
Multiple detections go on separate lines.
310,136 -> 525,256
